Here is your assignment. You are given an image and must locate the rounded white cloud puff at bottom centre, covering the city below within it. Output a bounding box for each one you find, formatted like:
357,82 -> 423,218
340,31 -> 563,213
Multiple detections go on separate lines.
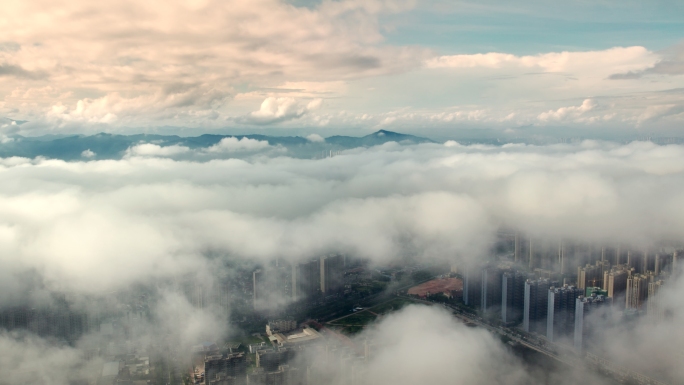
360,306 -> 532,385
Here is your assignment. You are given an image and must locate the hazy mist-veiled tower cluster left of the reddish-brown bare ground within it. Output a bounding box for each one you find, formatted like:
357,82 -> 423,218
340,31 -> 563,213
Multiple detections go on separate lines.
252,254 -> 346,309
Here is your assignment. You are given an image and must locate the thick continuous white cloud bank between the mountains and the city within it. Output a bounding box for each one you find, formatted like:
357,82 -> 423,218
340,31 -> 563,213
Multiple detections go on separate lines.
0,142 -> 684,296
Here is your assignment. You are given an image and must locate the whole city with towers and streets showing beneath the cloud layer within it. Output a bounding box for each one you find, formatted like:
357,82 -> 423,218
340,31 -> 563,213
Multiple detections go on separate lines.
0,232 -> 681,385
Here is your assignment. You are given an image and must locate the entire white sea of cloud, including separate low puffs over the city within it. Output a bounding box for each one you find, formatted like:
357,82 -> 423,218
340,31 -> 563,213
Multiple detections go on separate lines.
0,141 -> 684,383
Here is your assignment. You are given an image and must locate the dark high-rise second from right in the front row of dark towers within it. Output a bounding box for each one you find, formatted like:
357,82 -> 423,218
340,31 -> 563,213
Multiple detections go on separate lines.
546,285 -> 584,342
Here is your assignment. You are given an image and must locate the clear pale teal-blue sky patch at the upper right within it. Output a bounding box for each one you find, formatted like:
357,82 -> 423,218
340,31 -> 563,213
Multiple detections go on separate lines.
387,1 -> 684,55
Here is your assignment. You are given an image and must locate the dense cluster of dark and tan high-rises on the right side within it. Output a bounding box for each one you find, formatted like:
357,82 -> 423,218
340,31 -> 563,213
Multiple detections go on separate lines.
463,236 -> 678,351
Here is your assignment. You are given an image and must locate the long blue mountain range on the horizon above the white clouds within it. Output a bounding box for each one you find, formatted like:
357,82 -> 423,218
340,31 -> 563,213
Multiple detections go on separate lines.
0,130 -> 434,160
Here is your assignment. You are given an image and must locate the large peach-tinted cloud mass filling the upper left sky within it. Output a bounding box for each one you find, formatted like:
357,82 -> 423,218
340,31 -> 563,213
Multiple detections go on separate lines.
0,0 -> 429,127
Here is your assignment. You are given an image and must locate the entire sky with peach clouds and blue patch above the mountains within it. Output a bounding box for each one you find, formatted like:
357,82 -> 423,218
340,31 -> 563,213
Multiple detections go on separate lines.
0,0 -> 684,139
